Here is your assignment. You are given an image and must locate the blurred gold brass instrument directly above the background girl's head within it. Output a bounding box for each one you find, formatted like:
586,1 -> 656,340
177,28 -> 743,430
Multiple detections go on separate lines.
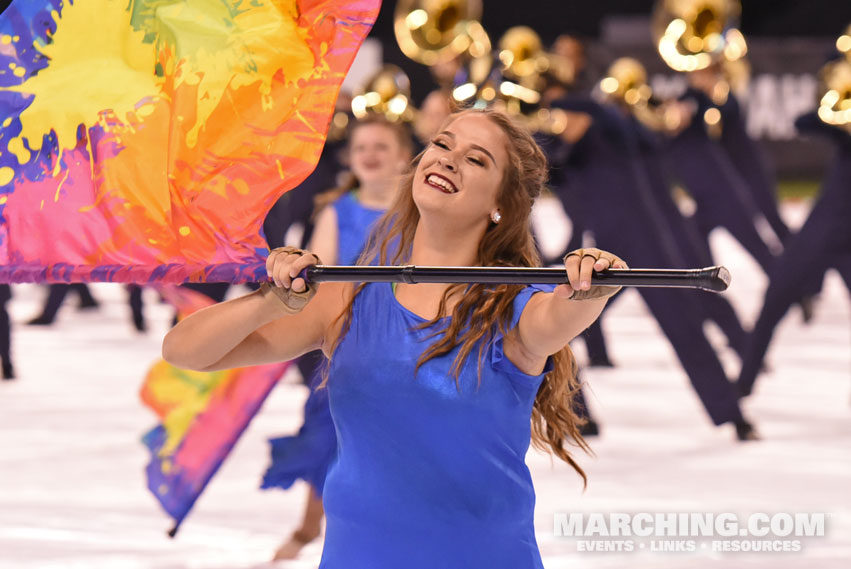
352,65 -> 415,122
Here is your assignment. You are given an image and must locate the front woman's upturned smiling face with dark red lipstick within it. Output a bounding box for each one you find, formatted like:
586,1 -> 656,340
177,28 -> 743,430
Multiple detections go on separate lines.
412,113 -> 508,229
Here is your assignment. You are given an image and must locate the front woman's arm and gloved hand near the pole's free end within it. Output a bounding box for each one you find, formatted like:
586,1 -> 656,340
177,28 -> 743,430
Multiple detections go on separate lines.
504,249 -> 627,375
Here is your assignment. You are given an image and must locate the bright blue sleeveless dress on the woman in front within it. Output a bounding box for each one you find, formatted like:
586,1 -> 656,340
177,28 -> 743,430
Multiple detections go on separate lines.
320,283 -> 553,569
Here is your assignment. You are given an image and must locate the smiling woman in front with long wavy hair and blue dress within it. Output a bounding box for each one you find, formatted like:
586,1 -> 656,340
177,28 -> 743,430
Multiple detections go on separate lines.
163,110 -> 625,569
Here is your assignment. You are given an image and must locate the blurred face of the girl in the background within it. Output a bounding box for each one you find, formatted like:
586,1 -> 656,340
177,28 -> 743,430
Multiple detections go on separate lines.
349,124 -> 409,184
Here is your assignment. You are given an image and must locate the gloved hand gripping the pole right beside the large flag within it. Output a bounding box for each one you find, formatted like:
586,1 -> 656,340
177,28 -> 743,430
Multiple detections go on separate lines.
260,247 -> 321,314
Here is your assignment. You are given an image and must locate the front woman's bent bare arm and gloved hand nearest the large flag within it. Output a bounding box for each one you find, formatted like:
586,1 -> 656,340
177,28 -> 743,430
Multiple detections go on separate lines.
162,250 -> 351,371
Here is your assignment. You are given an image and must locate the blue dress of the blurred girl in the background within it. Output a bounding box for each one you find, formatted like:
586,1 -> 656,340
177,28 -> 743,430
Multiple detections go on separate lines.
260,192 -> 384,496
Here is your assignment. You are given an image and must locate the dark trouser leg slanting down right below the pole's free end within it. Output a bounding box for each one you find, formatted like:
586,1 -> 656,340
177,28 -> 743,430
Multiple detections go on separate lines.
638,288 -> 742,425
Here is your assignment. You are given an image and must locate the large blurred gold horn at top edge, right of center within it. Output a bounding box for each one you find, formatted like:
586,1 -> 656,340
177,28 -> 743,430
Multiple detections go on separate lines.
652,0 -> 747,71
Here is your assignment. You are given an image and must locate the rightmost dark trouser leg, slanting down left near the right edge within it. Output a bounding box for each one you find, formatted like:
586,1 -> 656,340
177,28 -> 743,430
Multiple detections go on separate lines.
738,200 -> 841,394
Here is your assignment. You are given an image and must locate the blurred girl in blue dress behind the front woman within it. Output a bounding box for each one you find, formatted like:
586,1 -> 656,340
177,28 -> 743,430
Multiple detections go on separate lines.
262,115 -> 413,560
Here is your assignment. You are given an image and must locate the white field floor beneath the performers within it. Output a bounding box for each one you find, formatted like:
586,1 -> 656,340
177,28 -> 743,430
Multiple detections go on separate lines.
0,196 -> 851,569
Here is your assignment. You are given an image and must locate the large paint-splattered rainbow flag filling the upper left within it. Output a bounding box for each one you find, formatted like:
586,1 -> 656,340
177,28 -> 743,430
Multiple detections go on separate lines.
0,0 -> 380,283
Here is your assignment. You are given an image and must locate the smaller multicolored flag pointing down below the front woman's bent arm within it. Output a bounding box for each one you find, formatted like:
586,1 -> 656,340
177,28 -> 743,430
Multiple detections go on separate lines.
140,286 -> 289,536
